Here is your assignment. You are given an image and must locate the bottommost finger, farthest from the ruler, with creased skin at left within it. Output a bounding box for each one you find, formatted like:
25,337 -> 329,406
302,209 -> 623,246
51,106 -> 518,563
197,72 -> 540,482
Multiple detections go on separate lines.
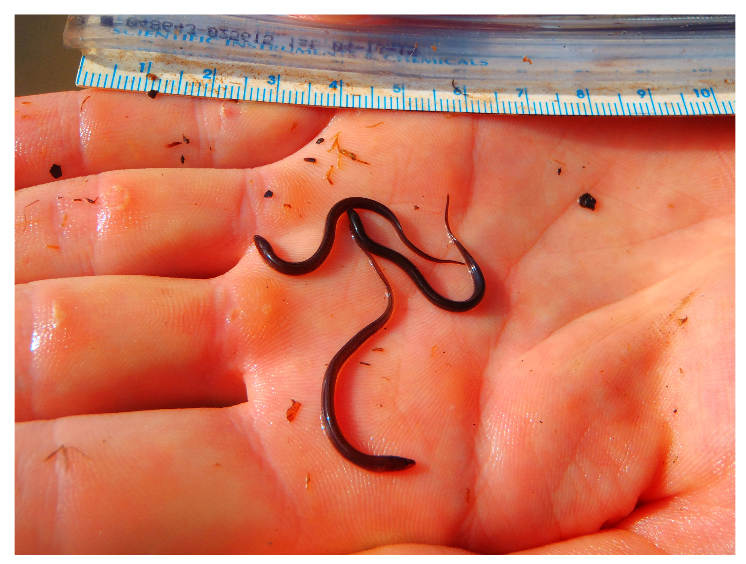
16,410 -> 288,554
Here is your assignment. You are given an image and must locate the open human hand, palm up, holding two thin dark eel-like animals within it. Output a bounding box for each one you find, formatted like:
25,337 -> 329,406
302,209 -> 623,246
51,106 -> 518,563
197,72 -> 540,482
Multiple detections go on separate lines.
16,90 -> 735,553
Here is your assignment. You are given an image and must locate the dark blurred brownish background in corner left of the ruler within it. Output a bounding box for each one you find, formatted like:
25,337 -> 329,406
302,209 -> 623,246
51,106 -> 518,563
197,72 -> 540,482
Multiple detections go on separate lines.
15,15 -> 80,96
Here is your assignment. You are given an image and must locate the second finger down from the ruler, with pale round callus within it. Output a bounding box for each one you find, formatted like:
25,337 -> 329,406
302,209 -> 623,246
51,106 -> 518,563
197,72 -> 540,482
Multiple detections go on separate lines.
15,169 -> 256,283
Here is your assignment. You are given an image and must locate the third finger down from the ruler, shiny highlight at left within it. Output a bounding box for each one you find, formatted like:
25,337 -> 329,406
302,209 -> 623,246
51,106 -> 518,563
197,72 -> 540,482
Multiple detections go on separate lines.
16,276 -> 246,421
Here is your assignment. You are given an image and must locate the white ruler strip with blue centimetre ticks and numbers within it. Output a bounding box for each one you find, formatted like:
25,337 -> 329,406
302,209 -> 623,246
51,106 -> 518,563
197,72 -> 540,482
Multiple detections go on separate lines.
76,50 -> 735,116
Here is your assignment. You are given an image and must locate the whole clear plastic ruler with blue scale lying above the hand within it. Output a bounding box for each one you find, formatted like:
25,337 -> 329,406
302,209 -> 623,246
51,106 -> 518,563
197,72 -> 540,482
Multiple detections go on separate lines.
65,15 -> 735,116
